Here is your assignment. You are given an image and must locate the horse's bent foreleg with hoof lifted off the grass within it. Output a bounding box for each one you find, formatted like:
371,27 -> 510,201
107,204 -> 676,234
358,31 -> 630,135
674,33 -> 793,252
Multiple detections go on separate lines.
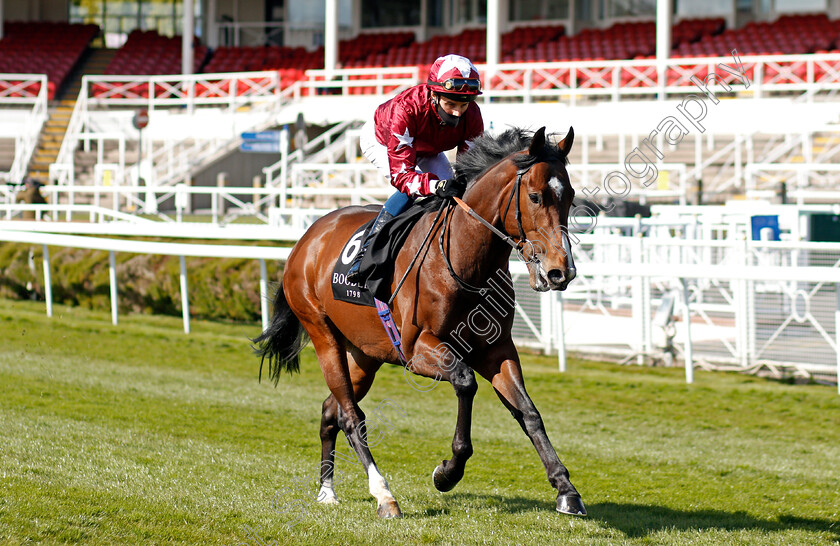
408,334 -> 478,492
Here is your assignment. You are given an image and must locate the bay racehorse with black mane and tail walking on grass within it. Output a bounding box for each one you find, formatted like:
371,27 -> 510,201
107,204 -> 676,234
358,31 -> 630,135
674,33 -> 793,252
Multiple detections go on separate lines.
253,127 -> 586,518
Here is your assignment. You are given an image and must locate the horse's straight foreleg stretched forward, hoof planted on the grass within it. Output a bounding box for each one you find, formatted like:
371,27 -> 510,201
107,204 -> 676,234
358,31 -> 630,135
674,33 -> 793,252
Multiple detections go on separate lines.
476,343 -> 586,516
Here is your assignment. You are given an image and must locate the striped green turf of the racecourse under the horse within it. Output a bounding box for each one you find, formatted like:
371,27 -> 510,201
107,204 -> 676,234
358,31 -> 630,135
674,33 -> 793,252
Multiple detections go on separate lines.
0,301 -> 840,544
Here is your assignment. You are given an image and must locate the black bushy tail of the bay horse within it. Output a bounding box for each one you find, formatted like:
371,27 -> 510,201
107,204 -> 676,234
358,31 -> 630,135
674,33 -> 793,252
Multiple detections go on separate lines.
251,283 -> 309,385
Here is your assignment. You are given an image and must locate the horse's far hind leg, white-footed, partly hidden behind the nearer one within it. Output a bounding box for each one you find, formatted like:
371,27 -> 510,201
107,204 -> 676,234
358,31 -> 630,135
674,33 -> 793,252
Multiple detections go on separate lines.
318,353 -> 382,504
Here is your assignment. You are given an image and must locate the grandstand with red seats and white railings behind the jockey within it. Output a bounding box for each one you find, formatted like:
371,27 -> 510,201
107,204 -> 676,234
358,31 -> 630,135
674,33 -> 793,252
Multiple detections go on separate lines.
0,0 -> 840,205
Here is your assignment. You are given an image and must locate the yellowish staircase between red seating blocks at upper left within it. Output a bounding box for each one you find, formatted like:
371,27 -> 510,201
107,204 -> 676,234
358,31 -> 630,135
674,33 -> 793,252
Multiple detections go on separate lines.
29,48 -> 116,183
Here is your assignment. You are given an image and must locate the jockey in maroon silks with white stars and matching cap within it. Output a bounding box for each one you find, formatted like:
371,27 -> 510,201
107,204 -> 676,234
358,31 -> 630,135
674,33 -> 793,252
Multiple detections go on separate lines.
347,54 -> 484,283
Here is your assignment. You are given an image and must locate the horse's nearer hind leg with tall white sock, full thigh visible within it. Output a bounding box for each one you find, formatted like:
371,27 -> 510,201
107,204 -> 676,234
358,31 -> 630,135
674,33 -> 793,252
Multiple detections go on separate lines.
301,315 -> 402,518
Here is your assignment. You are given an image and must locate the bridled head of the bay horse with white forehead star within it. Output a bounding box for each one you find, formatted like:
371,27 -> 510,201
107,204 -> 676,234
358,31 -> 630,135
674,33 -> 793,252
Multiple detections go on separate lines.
500,127 -> 576,292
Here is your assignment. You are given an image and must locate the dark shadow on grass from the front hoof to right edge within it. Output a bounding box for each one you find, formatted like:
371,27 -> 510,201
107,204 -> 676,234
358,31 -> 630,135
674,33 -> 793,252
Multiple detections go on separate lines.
587,502 -> 840,540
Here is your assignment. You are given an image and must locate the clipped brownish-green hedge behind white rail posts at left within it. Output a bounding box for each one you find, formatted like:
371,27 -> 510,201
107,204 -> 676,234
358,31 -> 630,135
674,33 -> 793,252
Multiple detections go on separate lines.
0,242 -> 282,321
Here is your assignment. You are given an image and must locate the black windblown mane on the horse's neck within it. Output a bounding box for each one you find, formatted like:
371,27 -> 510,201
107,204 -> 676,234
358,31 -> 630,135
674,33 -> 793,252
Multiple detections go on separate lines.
453,127 -> 569,187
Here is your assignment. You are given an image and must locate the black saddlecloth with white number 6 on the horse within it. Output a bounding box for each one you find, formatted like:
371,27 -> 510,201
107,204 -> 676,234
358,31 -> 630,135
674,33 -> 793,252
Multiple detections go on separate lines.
332,196 -> 440,307
